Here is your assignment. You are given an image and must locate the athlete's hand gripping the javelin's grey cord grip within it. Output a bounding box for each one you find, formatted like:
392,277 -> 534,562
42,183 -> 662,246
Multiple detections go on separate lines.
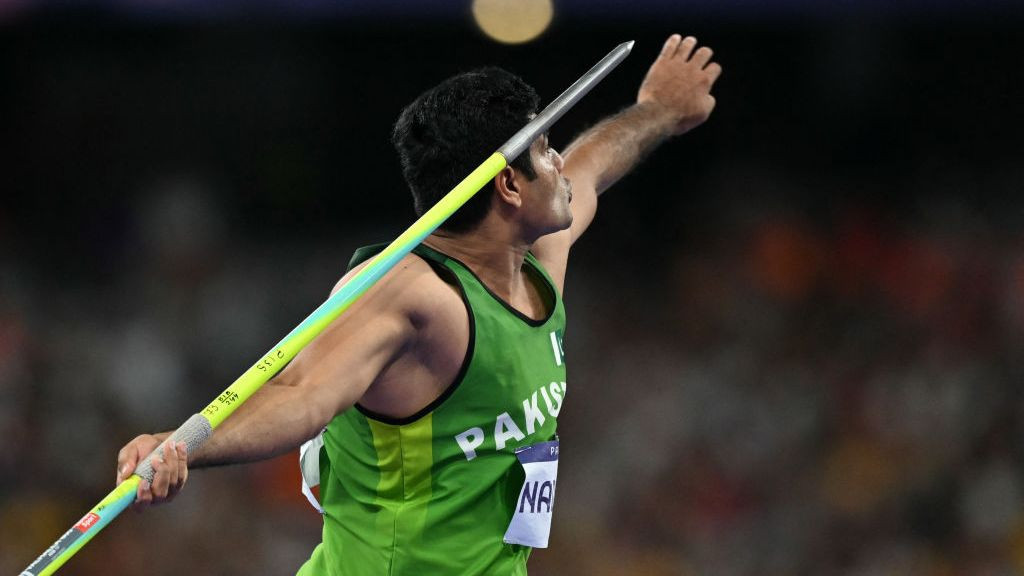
117,435 -> 188,511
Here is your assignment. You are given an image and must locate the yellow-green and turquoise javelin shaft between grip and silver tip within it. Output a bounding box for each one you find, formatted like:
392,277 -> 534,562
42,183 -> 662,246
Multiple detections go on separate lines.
201,152 -> 508,428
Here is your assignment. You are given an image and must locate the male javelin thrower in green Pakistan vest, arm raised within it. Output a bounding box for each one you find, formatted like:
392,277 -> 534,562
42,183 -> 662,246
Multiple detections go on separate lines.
118,35 -> 721,576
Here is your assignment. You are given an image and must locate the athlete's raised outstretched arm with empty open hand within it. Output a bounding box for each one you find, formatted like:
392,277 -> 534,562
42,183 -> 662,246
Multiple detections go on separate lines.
534,34 -> 722,286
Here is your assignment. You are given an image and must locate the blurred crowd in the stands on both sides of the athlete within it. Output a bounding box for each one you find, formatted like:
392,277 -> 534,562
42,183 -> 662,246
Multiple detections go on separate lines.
6,156 -> 1024,576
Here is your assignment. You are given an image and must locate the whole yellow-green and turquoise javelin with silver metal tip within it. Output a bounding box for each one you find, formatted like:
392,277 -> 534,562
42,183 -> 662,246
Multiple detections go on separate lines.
20,41 -> 633,576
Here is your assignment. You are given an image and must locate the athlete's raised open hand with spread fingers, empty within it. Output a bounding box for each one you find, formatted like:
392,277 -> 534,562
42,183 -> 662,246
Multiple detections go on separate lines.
637,34 -> 722,135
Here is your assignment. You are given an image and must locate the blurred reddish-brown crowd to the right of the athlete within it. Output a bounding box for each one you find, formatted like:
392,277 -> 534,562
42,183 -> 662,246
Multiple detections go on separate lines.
543,152 -> 1024,576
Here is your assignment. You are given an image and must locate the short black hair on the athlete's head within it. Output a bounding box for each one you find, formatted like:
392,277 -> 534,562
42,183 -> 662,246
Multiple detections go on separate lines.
392,68 -> 540,232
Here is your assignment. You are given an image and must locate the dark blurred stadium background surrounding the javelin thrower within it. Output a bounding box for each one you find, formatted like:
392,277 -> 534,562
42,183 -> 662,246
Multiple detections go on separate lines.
0,0 -> 1024,576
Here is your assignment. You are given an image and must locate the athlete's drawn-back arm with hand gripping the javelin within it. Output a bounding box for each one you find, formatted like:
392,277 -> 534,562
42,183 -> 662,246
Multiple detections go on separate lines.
117,257 -> 429,509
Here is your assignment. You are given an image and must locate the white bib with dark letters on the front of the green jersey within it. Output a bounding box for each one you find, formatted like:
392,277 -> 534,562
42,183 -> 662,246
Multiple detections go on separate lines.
505,440 -> 558,548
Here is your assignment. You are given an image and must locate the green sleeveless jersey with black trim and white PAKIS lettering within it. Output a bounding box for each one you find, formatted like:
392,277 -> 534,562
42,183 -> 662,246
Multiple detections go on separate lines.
299,245 -> 565,576
